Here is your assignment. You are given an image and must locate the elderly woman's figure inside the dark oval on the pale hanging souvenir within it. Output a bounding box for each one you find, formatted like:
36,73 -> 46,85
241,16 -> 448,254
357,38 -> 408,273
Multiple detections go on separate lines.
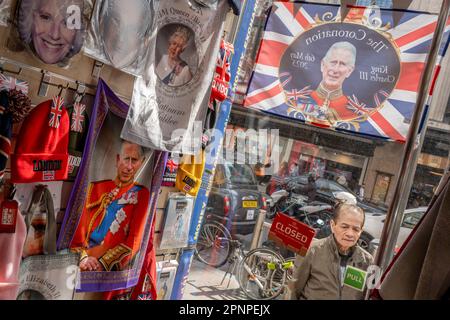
156,26 -> 192,86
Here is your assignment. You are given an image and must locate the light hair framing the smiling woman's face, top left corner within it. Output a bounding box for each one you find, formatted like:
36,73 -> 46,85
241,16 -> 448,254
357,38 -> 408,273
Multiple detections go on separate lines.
17,0 -> 88,62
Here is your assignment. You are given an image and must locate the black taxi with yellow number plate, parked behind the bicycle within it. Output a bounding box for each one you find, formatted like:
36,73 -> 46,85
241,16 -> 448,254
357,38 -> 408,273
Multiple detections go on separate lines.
205,161 -> 266,235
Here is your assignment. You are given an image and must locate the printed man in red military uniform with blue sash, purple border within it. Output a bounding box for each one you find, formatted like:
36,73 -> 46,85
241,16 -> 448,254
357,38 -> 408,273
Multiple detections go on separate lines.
70,141 -> 150,271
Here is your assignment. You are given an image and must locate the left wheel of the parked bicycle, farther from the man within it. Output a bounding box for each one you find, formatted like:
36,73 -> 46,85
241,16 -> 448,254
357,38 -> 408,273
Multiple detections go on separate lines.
195,222 -> 231,268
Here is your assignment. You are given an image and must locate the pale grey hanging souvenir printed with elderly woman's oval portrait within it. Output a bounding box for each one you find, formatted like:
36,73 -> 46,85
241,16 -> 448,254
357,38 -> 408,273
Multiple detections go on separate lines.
121,0 -> 229,155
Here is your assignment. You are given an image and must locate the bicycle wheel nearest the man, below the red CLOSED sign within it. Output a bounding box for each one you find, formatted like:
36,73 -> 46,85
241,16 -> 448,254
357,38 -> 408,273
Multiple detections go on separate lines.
237,248 -> 286,300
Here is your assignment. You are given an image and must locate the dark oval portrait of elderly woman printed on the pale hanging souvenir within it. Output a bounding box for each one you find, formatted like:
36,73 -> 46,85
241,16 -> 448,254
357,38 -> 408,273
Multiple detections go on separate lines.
155,24 -> 198,87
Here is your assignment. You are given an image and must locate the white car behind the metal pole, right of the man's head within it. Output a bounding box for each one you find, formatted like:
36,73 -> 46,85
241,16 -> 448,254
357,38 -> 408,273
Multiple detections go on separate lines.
360,207 -> 428,253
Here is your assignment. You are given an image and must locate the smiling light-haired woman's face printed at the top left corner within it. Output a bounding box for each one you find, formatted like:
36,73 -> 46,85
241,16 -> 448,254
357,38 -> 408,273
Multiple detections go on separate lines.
18,0 -> 85,64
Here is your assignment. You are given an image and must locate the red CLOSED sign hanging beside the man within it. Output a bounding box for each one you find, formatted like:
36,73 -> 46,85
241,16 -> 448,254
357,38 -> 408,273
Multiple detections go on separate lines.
269,213 -> 316,257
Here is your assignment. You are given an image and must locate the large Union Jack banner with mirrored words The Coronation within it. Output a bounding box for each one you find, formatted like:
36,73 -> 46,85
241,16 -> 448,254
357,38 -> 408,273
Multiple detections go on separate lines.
245,2 -> 444,142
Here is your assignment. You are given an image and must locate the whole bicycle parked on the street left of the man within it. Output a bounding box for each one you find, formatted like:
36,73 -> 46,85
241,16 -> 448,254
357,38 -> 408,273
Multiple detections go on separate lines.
196,222 -> 294,300
